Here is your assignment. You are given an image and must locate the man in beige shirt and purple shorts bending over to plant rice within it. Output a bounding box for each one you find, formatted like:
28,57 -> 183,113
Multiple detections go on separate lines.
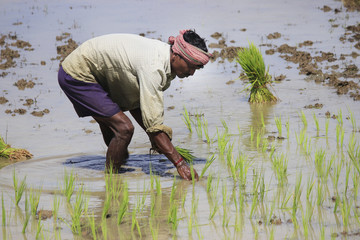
58,30 -> 211,180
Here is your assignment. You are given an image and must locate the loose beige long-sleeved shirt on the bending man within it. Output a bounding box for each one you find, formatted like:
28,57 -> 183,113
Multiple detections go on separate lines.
62,34 -> 174,138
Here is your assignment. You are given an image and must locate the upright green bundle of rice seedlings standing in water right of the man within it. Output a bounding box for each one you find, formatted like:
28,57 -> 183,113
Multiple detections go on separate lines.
236,43 -> 277,103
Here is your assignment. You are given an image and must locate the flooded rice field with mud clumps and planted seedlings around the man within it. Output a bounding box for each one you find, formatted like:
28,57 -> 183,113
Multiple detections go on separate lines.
0,0 -> 360,239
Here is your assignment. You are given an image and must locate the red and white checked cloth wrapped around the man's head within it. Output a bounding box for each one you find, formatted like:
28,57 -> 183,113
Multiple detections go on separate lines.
169,30 -> 211,65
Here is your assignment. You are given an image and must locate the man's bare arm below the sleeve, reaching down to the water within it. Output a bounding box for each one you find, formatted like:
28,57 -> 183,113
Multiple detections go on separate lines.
130,108 -> 199,180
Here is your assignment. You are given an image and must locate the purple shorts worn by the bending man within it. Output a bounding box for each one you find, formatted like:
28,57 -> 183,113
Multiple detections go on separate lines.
58,66 -> 121,117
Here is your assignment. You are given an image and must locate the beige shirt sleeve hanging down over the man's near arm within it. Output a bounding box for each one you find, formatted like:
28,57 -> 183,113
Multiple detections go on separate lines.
137,66 -> 172,139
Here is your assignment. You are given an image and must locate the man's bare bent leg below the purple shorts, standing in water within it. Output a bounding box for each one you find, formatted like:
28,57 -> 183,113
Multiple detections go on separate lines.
93,112 -> 134,171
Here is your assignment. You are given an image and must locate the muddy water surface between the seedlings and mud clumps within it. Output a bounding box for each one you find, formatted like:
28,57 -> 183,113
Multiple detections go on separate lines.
0,0 -> 360,239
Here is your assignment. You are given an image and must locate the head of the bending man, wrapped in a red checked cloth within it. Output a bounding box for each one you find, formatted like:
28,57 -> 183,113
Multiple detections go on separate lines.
169,30 -> 211,78
